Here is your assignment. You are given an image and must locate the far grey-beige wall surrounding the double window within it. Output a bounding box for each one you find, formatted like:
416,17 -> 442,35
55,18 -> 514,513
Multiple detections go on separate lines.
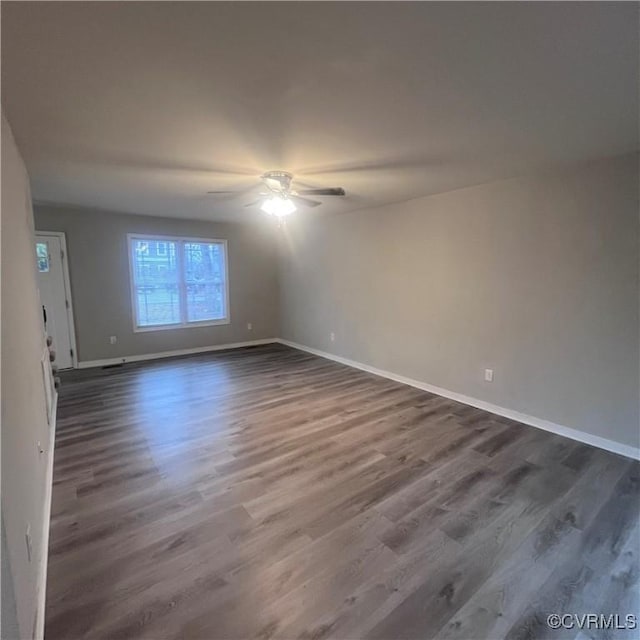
35,206 -> 279,362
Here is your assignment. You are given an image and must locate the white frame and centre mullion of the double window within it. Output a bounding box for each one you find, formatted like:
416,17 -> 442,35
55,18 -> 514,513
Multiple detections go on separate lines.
127,233 -> 231,333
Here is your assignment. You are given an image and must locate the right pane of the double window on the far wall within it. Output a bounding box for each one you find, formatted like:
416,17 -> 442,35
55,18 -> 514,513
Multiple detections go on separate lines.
184,242 -> 227,322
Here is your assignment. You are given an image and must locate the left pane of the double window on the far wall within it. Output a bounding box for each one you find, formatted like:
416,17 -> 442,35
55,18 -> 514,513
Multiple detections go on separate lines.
131,239 -> 181,327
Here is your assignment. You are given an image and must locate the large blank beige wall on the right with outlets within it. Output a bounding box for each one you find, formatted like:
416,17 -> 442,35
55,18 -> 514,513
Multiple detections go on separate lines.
280,156 -> 639,447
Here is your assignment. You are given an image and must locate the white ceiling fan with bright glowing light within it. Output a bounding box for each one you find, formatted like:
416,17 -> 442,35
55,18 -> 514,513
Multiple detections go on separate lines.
207,171 -> 346,218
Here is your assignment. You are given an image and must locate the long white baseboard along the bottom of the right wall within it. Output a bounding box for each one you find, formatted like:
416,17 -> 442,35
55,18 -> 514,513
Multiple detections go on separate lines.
277,339 -> 640,460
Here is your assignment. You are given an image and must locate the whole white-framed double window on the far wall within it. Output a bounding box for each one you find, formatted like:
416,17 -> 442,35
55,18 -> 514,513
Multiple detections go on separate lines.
129,235 -> 229,331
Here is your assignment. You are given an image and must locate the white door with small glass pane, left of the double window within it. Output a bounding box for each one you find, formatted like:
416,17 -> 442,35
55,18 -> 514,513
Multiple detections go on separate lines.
36,233 -> 74,369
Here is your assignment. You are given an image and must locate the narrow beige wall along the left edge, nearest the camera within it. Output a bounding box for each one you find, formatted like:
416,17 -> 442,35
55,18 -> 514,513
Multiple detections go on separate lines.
2,115 -> 53,638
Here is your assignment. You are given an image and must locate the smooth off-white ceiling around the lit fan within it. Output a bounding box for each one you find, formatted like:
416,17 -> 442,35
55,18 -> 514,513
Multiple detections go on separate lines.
2,2 -> 638,221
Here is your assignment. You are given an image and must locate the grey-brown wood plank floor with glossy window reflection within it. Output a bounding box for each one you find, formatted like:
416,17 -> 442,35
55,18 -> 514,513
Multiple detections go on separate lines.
46,345 -> 640,640
